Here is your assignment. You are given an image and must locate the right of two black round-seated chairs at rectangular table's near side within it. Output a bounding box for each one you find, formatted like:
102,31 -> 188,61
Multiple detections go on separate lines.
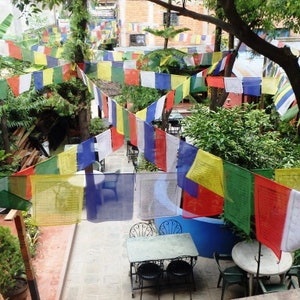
166,256 -> 196,300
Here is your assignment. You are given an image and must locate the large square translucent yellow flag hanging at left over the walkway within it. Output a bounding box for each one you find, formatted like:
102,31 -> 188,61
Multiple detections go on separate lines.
30,175 -> 84,226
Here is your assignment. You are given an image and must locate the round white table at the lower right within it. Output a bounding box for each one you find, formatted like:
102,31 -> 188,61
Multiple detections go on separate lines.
232,241 -> 293,296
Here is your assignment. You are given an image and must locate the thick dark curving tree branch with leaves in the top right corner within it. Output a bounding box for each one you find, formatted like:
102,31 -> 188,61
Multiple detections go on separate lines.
148,0 -> 300,113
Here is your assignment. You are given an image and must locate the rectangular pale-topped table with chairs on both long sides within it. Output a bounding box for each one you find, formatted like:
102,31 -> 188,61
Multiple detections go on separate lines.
127,233 -> 199,295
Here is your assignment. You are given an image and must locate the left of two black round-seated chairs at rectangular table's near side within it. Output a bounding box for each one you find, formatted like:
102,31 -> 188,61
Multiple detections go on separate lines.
137,261 -> 163,299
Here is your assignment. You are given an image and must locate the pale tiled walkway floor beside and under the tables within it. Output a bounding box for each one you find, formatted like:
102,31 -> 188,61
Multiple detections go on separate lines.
61,149 -> 244,300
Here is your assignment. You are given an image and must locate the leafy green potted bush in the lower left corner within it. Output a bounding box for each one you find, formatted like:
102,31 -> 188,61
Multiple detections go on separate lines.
0,226 -> 25,294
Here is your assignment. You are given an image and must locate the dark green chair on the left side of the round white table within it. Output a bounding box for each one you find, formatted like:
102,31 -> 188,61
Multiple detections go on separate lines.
213,252 -> 247,300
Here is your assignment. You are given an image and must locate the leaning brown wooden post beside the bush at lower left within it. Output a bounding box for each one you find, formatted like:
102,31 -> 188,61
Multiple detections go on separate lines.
14,211 -> 40,300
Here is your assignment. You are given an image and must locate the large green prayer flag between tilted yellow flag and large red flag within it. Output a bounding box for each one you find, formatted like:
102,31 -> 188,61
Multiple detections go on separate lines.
224,161 -> 254,235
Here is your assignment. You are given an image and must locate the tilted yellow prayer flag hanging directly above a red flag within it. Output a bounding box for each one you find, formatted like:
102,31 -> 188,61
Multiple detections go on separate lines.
186,149 -> 224,197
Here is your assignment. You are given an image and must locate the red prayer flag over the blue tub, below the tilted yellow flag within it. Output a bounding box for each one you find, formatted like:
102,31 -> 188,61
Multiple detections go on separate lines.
182,185 -> 224,218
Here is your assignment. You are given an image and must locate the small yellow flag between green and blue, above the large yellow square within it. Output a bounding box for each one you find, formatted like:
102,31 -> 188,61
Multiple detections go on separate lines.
57,145 -> 77,175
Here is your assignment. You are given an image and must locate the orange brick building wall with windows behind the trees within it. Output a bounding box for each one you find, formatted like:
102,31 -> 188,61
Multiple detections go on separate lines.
119,0 -> 215,47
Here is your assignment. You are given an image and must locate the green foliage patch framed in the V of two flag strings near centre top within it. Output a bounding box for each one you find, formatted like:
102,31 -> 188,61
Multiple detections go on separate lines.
115,85 -> 162,113
